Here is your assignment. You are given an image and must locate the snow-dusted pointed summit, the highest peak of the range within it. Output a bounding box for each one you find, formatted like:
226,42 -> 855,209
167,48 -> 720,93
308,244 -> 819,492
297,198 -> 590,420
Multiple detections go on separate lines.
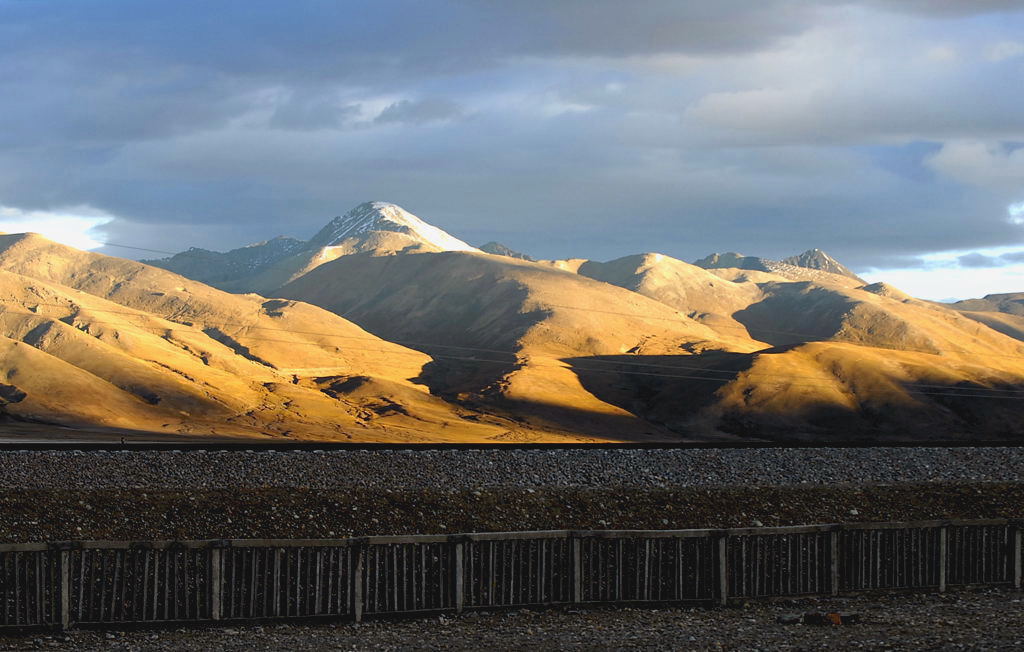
310,202 -> 479,252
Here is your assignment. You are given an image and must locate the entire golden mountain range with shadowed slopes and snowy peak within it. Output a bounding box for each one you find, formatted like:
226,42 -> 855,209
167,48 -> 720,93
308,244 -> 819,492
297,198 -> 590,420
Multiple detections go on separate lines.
0,202 -> 1024,442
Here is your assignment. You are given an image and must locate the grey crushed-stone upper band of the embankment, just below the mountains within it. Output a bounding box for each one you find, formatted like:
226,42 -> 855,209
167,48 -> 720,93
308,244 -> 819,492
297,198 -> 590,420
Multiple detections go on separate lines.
0,447 -> 1024,490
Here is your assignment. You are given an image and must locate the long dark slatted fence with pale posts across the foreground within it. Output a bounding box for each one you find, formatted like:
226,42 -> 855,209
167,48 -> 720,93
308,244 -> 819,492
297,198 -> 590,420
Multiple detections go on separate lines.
0,520 -> 1024,627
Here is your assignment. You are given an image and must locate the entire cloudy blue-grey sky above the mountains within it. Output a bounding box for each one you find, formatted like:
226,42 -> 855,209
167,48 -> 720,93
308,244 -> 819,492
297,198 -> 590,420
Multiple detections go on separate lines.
0,0 -> 1024,299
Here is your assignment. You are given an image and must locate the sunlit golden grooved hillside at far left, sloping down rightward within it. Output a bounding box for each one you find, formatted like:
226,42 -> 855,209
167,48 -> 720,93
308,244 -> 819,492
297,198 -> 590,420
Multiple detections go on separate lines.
0,234 -> 536,441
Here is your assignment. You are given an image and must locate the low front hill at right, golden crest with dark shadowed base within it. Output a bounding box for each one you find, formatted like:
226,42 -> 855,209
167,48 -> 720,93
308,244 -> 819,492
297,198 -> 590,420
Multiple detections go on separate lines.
572,342 -> 1024,442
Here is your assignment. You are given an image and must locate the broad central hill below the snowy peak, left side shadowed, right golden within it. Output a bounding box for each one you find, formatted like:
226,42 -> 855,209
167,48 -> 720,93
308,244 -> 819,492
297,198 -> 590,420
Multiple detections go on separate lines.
280,253 -> 762,436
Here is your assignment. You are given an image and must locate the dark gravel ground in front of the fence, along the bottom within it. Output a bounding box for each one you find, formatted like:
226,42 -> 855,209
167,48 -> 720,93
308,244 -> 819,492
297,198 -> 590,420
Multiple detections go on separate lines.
0,591 -> 1024,650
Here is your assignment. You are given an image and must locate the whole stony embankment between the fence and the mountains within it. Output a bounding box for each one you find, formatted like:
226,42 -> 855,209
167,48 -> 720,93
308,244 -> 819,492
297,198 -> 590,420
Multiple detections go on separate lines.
0,448 -> 1024,542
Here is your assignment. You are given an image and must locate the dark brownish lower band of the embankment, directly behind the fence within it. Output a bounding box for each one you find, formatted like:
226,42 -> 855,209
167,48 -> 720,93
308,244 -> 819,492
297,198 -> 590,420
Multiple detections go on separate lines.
0,482 -> 1024,542
